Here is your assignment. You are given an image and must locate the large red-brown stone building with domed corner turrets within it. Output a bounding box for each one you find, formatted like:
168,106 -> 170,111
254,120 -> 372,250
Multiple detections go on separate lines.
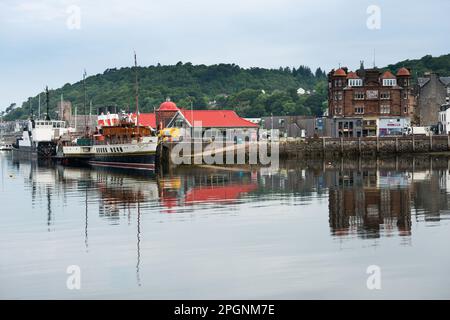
328,63 -> 415,137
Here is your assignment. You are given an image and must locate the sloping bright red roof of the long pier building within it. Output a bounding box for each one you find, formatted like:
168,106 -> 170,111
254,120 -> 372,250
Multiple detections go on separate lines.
180,109 -> 258,128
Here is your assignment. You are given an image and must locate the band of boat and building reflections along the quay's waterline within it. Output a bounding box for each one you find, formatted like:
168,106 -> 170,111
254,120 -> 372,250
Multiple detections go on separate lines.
5,156 -> 450,240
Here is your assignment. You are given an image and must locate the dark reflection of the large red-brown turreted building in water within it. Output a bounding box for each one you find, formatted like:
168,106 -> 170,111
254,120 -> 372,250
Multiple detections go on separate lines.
329,171 -> 411,238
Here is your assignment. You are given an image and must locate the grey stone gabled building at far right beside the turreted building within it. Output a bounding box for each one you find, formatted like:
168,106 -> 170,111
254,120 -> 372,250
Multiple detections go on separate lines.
416,73 -> 450,127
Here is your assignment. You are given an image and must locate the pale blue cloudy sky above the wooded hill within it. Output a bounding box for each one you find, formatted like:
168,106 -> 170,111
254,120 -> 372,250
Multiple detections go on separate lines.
0,0 -> 450,110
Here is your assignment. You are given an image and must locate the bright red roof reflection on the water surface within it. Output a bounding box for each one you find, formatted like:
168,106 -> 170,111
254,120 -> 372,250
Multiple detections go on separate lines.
185,184 -> 257,204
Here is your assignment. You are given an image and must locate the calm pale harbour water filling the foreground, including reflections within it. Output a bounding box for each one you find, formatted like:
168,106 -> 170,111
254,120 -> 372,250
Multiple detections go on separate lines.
0,154 -> 450,299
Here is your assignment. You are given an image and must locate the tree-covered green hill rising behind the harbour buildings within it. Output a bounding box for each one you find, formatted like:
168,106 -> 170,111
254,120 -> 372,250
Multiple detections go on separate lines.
4,54 -> 450,120
